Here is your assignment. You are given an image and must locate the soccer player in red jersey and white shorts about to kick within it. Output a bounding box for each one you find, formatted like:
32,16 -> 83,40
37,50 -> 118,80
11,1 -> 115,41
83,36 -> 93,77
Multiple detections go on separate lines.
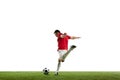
54,30 -> 80,75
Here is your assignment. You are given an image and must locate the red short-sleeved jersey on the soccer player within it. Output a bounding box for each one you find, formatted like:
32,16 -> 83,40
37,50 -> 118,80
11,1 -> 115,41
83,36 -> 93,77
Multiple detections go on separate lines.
57,33 -> 71,50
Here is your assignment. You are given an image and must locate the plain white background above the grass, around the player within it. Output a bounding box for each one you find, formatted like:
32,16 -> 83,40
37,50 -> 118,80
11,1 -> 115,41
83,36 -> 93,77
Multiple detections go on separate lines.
0,0 -> 120,71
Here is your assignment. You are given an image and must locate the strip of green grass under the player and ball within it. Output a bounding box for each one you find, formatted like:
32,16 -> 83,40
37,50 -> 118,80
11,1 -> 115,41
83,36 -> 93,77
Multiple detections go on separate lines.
0,71 -> 120,80
